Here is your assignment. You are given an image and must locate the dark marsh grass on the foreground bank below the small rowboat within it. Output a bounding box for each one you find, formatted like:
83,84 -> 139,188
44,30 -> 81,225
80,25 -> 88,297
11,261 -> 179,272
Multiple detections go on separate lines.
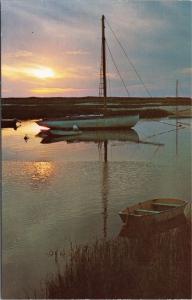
37,222 -> 191,299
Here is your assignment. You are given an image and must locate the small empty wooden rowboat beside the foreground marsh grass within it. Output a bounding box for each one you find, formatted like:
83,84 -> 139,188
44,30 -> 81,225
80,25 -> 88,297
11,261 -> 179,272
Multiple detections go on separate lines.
119,198 -> 188,224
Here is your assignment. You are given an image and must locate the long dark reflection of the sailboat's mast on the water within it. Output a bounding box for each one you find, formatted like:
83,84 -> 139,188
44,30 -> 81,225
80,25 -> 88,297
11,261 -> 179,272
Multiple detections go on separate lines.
102,141 -> 108,239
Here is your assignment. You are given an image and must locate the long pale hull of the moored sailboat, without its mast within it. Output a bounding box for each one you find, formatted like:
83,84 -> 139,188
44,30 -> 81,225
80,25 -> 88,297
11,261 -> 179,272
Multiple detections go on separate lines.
37,115 -> 139,130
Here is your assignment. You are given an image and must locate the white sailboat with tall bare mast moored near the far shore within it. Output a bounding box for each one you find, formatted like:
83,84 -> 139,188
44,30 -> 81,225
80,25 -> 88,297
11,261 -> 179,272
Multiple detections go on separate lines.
37,15 -> 139,131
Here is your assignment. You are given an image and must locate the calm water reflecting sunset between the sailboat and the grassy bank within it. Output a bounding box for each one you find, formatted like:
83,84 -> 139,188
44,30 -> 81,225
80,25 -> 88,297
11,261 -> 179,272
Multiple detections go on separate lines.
2,119 -> 191,298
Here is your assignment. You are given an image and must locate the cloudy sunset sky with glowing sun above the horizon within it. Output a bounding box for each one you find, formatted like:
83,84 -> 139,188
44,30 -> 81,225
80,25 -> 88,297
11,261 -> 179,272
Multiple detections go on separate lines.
1,0 -> 192,97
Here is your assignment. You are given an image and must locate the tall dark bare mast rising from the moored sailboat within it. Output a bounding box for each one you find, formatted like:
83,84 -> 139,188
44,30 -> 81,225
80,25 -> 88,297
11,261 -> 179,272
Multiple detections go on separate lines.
102,15 -> 107,111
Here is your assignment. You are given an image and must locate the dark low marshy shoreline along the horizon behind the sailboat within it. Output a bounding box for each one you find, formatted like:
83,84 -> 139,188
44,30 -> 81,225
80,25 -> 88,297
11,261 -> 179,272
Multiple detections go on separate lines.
1,97 -> 192,120
